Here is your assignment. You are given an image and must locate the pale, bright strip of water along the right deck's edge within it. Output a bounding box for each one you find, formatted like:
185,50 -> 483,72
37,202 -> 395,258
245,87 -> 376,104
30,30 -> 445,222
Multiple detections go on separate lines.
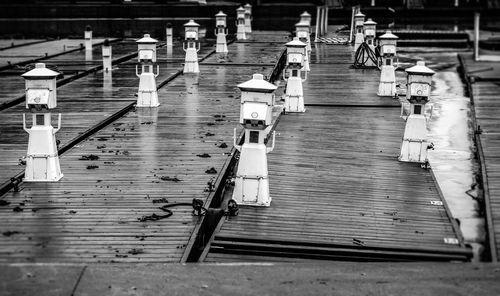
428,69 -> 485,258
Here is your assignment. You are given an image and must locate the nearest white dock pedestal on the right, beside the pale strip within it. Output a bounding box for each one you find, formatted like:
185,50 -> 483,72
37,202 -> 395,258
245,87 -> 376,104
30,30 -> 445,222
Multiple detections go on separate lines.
399,61 -> 435,163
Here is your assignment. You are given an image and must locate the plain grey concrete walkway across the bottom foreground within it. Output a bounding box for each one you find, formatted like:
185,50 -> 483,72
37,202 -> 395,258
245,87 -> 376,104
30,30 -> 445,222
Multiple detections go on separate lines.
0,262 -> 500,296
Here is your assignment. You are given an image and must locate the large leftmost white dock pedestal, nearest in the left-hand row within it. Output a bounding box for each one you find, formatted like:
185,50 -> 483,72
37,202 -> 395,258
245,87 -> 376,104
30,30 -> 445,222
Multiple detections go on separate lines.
21,63 -> 63,182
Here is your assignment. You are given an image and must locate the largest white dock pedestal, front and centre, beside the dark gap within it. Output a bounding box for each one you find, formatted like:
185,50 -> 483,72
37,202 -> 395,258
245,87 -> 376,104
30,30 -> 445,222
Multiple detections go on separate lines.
233,74 -> 277,206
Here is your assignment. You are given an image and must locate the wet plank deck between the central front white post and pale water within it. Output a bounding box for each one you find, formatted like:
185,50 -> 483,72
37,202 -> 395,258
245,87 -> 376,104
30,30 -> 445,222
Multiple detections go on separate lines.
205,44 -> 471,262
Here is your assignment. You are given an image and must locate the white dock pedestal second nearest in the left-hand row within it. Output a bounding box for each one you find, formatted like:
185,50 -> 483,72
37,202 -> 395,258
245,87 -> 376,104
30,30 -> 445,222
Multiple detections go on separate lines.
135,34 -> 160,107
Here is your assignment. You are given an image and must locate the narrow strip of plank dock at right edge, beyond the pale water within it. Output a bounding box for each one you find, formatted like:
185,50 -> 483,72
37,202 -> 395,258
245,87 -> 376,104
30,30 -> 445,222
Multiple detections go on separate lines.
459,54 -> 500,262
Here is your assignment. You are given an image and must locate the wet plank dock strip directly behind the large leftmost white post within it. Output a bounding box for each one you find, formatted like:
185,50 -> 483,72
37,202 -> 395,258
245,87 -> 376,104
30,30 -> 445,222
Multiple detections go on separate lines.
0,41 -> 212,183
